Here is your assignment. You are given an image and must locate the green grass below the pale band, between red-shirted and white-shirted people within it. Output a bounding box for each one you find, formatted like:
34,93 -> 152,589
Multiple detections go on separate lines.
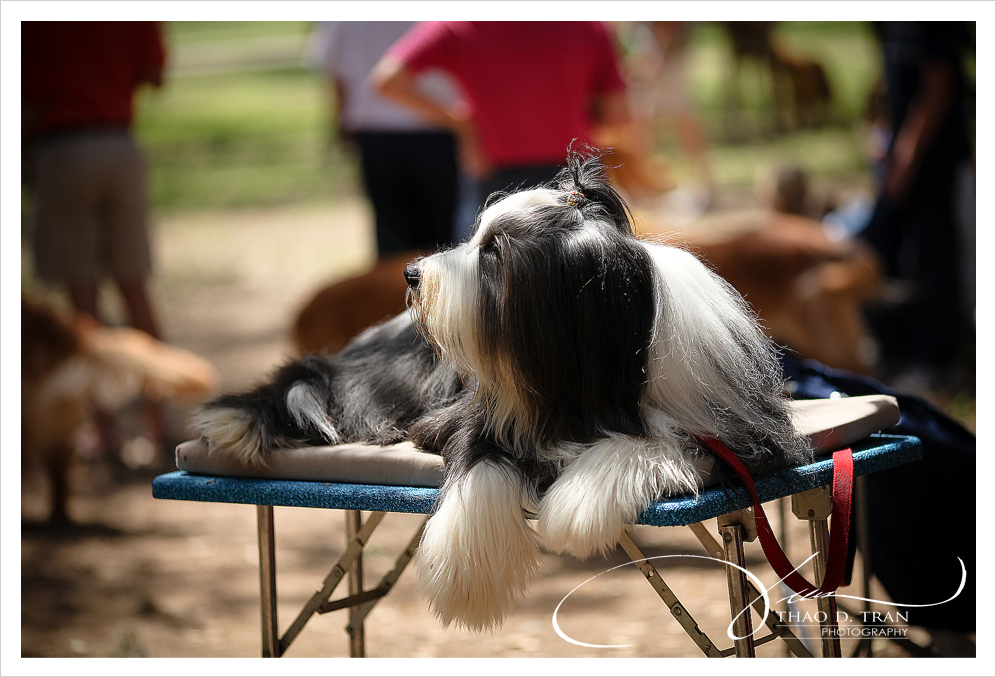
138,69 -> 355,209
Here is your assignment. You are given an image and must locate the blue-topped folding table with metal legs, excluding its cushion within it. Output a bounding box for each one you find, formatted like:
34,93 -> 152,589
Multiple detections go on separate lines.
152,435 -> 921,658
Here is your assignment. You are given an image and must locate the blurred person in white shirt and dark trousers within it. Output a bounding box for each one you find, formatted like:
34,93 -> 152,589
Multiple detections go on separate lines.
309,21 -> 459,257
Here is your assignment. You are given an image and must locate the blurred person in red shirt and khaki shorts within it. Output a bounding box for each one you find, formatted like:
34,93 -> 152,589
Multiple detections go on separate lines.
21,21 -> 166,453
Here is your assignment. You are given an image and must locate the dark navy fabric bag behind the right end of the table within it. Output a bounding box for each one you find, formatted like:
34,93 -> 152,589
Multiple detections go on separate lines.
782,355 -> 977,632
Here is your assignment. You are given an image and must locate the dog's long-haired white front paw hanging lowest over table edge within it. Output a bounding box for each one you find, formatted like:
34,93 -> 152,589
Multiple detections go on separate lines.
416,461 -> 541,631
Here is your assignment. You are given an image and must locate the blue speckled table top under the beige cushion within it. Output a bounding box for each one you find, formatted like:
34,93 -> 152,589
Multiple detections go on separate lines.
152,435 -> 922,526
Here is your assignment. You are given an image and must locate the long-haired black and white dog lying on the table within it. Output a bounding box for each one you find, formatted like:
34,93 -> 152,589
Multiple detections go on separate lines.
196,156 -> 811,630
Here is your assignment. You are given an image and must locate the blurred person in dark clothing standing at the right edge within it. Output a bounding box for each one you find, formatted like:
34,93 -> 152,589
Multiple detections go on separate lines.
862,22 -> 974,391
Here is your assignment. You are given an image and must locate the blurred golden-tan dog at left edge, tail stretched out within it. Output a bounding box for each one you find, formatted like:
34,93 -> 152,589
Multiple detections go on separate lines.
21,297 -> 218,521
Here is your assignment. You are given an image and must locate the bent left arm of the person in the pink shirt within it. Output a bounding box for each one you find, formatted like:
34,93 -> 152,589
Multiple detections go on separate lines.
370,54 -> 490,176
